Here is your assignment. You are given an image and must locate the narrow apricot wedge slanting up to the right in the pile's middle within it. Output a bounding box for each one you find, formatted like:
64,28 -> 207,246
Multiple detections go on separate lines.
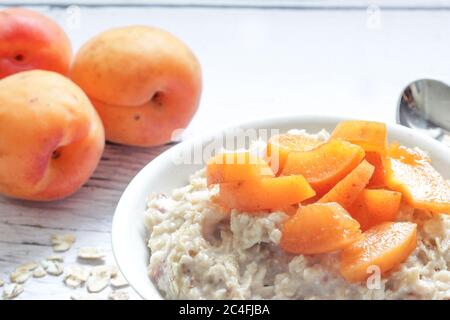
318,160 -> 374,210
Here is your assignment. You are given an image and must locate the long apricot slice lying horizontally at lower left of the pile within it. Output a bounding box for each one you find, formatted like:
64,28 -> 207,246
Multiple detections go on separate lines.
217,175 -> 316,212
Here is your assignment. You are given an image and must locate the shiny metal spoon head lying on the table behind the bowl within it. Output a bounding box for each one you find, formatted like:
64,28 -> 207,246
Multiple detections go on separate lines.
397,79 -> 450,141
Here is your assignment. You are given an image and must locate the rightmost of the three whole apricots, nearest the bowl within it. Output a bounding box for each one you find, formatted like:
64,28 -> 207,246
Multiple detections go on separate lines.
70,26 -> 202,147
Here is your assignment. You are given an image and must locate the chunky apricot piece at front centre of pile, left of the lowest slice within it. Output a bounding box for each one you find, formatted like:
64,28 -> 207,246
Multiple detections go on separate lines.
280,202 -> 361,254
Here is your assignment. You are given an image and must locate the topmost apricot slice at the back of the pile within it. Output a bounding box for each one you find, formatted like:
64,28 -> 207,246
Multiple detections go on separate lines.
331,120 -> 388,155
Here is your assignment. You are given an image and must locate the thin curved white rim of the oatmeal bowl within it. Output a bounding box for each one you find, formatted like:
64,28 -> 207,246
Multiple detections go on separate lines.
111,114 -> 450,299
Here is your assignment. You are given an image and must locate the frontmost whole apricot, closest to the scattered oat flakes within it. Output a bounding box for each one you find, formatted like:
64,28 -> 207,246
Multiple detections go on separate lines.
0,70 -> 105,201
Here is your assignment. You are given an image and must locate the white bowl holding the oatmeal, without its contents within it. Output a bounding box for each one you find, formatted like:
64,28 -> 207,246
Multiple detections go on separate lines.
112,116 -> 450,299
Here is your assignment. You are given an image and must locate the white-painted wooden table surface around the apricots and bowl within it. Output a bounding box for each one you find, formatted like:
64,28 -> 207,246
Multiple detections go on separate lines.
0,0 -> 450,299
